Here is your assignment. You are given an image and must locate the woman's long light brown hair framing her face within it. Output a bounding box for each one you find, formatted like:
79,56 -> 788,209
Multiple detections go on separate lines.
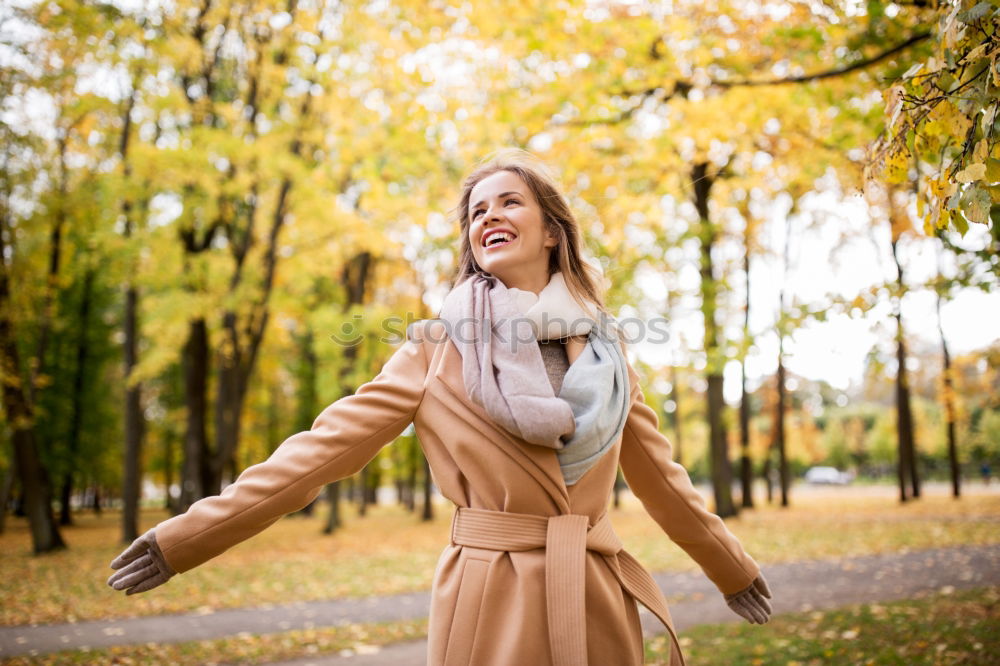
452,148 -> 607,313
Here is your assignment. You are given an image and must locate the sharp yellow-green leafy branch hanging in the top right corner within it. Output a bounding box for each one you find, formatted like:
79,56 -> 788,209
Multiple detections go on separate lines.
866,0 -> 1000,236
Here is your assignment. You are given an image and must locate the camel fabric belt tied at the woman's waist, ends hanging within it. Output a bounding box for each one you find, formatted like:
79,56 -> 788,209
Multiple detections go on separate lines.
451,508 -> 684,666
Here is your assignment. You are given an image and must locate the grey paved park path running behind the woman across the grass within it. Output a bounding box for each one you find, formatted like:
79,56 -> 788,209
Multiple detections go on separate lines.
0,544 -> 1000,666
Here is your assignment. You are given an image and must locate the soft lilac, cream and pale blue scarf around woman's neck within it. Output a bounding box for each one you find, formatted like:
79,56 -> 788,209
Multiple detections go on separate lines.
441,272 -> 629,485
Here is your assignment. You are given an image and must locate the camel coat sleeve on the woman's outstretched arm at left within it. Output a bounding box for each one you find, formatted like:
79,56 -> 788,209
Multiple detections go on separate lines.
156,326 -> 429,573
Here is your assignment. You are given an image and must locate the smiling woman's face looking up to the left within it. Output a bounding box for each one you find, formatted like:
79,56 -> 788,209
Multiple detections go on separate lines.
468,171 -> 558,293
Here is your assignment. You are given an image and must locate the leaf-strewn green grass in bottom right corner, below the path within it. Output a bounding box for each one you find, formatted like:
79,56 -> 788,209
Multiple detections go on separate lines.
646,587 -> 1000,666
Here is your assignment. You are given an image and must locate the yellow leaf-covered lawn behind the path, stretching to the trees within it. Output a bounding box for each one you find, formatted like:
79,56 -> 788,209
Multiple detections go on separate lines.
0,488 -> 1000,625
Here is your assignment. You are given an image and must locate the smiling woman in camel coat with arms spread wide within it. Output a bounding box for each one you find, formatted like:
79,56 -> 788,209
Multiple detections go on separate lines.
108,151 -> 771,665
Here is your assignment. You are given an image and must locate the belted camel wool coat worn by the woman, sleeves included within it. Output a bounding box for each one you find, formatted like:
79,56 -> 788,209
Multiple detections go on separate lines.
156,320 -> 759,666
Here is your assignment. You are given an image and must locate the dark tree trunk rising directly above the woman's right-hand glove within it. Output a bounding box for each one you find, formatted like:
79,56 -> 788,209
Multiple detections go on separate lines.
691,162 -> 737,518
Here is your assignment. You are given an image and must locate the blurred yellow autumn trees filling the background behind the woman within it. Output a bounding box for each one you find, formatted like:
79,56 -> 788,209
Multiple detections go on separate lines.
0,0 -> 1000,552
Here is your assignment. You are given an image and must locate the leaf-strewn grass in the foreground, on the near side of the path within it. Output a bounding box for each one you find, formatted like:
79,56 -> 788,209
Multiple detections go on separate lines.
6,587 -> 1000,666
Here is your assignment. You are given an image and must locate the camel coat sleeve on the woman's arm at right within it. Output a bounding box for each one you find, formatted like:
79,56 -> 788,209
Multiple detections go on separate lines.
619,364 -> 760,594
